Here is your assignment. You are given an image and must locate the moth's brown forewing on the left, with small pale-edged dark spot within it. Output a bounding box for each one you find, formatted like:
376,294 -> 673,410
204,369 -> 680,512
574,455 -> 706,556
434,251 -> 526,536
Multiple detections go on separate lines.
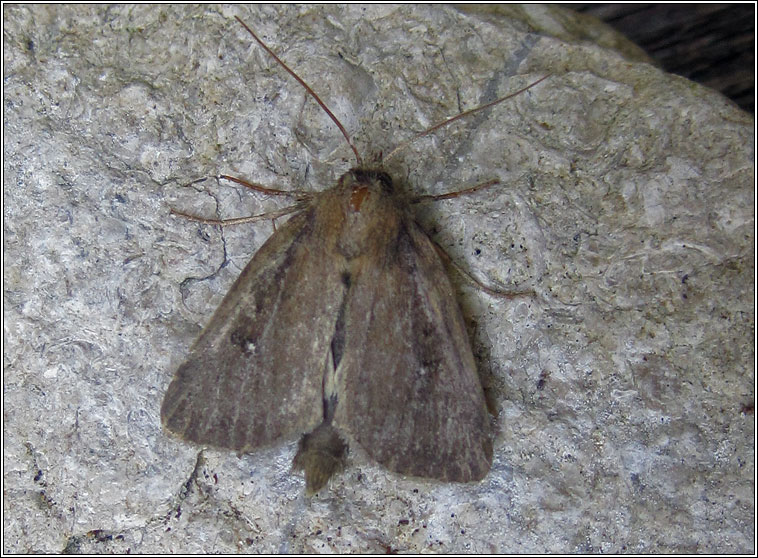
161,205 -> 345,451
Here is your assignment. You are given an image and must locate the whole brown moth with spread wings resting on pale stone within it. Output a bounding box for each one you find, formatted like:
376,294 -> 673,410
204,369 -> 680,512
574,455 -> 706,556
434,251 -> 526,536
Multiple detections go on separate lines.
161,18 -> 547,494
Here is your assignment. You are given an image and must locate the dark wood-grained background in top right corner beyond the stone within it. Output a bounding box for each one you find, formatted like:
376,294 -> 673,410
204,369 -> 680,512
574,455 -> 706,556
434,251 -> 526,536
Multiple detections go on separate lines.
564,2 -> 756,114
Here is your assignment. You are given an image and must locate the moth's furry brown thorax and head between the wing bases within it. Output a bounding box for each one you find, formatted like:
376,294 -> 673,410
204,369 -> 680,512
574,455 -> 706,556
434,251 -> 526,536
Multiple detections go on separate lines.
330,169 -> 404,260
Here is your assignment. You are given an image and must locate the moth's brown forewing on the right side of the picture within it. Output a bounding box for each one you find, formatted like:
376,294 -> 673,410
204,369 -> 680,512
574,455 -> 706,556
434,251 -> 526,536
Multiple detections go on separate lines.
334,218 -> 492,482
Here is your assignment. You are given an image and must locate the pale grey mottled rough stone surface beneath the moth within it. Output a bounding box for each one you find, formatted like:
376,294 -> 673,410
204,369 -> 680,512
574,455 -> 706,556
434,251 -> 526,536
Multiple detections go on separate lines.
3,5 -> 755,553
